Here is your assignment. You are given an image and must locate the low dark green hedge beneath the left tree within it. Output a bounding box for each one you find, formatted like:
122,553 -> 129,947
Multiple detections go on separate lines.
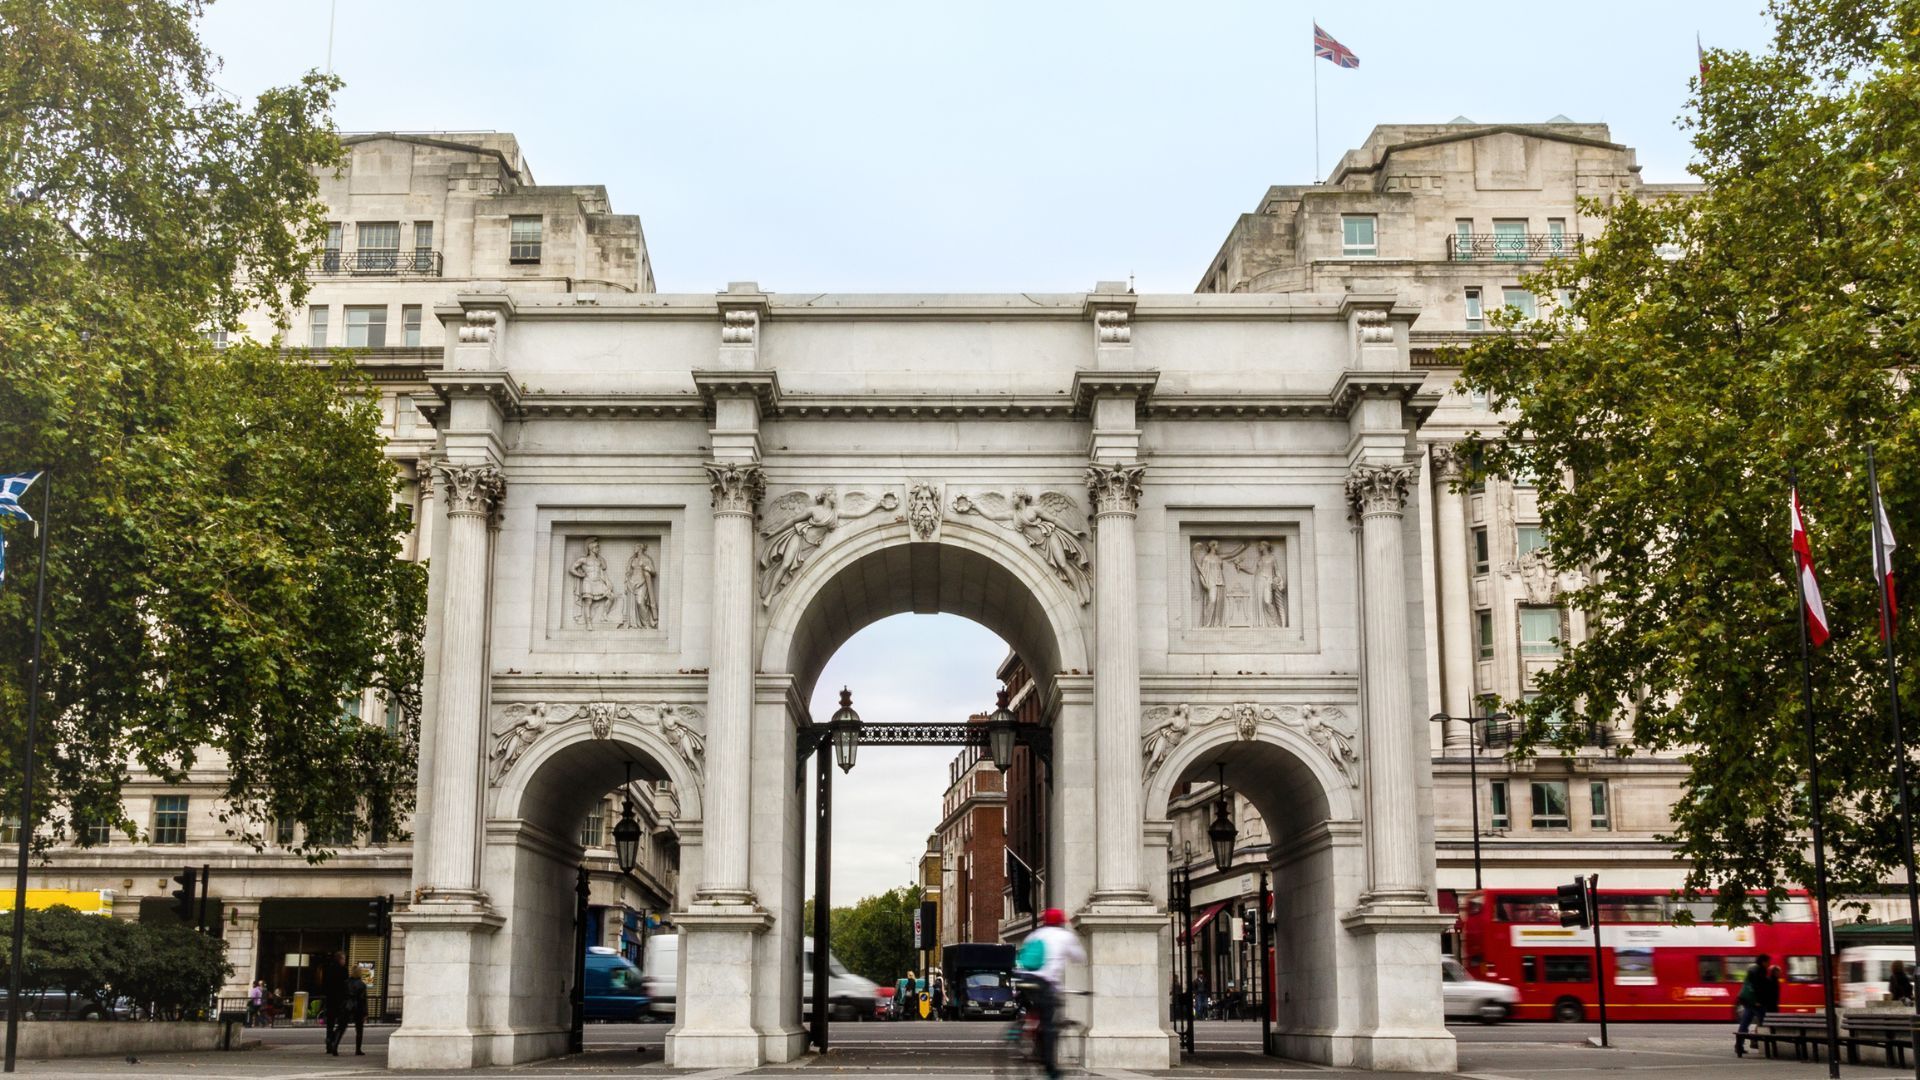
0,905 -> 232,1019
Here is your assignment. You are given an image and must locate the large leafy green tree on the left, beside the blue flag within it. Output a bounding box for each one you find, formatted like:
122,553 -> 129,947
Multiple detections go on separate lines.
0,0 -> 424,855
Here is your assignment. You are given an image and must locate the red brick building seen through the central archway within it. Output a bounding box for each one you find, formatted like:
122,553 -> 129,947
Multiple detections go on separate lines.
935,713 -> 1006,945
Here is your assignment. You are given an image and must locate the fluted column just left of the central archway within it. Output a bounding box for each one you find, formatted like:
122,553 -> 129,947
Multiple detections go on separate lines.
695,461 -> 766,903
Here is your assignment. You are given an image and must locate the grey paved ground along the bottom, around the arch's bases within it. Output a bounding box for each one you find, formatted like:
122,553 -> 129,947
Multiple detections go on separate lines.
21,1022 -> 1914,1080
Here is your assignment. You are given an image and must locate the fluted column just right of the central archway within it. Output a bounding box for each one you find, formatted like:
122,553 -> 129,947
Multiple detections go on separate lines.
1087,457 -> 1146,899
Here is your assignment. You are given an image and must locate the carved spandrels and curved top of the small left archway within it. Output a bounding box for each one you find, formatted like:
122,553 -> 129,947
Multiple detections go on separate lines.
486,701 -> 707,832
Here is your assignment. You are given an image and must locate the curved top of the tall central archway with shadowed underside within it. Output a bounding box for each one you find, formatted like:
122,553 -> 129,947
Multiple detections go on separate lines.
760,519 -> 1092,700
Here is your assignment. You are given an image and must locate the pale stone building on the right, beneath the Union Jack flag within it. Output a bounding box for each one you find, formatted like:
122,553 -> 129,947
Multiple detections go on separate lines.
1198,119 -> 1697,892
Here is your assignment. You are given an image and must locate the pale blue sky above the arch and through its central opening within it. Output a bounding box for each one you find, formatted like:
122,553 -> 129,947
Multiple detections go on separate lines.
187,0 -> 1770,903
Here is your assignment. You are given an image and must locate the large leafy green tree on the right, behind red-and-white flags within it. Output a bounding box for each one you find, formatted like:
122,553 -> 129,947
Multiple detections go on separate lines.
1463,0 -> 1920,919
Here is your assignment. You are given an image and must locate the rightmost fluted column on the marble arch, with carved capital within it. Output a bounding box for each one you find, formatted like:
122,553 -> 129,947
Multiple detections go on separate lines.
1346,461 -> 1428,903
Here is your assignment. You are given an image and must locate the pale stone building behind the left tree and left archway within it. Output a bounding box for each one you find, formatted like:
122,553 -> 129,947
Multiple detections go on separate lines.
11,133 -> 680,1011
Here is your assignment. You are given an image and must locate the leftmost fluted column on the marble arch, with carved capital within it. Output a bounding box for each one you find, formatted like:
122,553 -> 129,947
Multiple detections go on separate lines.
426,461 -> 507,897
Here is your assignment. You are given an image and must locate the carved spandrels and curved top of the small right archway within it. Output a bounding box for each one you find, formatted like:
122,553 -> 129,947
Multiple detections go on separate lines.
1140,701 -> 1361,826
